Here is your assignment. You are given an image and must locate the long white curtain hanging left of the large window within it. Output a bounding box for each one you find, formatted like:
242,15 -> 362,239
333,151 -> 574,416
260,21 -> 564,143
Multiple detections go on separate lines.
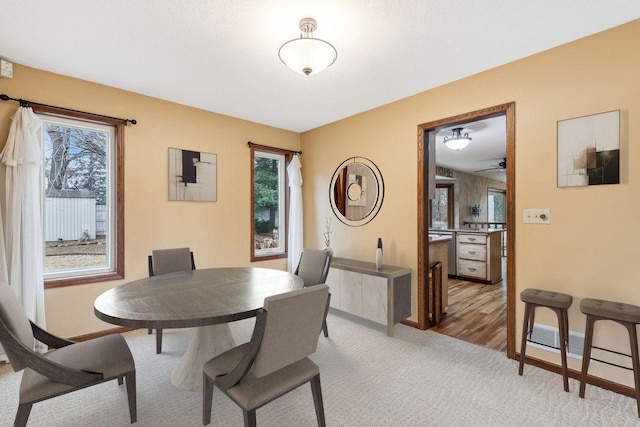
0,107 -> 46,358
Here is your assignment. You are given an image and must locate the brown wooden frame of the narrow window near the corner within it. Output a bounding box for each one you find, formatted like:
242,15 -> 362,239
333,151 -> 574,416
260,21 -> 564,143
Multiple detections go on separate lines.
250,145 -> 293,262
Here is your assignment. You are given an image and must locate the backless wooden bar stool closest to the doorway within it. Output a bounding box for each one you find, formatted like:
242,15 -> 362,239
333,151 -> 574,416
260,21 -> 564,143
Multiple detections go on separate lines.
518,289 -> 573,391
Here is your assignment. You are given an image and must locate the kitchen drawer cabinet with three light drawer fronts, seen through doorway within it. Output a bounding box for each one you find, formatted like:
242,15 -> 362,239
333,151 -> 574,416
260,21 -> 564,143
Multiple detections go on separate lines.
457,231 -> 502,284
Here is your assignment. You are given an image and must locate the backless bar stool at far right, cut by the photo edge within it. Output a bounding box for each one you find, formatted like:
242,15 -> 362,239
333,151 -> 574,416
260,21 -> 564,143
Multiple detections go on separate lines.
580,298 -> 640,417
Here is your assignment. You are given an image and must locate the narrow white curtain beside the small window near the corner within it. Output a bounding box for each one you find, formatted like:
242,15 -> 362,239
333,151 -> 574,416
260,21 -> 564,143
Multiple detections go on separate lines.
287,154 -> 303,273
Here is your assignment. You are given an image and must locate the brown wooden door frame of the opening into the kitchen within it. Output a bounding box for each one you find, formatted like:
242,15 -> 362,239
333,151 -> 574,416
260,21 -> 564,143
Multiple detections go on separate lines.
417,102 -> 516,359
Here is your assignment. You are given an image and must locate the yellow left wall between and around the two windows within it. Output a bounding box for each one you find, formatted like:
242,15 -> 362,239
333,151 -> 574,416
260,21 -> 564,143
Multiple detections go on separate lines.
0,64 -> 300,337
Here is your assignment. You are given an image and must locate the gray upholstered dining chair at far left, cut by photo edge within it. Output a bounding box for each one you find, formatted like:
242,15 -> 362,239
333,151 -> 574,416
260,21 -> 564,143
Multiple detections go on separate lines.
0,282 -> 137,426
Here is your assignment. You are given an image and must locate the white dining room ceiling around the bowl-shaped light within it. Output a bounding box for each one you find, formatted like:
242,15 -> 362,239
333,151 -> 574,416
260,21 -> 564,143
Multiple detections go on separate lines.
0,0 -> 640,137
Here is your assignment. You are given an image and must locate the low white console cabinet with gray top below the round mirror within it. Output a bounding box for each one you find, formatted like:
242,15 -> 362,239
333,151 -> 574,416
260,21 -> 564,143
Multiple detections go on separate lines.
326,257 -> 411,337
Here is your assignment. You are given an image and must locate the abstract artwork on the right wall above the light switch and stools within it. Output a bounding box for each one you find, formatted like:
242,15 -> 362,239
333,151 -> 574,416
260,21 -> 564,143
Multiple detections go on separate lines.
558,110 -> 620,187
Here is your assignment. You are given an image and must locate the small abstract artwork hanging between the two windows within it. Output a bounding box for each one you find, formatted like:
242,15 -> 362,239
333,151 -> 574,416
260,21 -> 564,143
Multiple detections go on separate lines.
169,148 -> 218,202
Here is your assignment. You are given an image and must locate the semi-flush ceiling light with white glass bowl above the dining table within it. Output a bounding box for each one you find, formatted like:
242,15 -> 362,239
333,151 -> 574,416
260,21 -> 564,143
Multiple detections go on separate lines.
278,18 -> 338,76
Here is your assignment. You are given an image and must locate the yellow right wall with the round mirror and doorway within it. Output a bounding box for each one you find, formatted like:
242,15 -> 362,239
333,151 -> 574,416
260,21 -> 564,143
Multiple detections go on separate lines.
302,21 -> 640,385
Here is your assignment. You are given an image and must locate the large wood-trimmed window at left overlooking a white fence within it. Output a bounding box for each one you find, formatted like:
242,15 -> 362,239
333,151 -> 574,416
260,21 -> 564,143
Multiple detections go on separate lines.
34,107 -> 124,288
